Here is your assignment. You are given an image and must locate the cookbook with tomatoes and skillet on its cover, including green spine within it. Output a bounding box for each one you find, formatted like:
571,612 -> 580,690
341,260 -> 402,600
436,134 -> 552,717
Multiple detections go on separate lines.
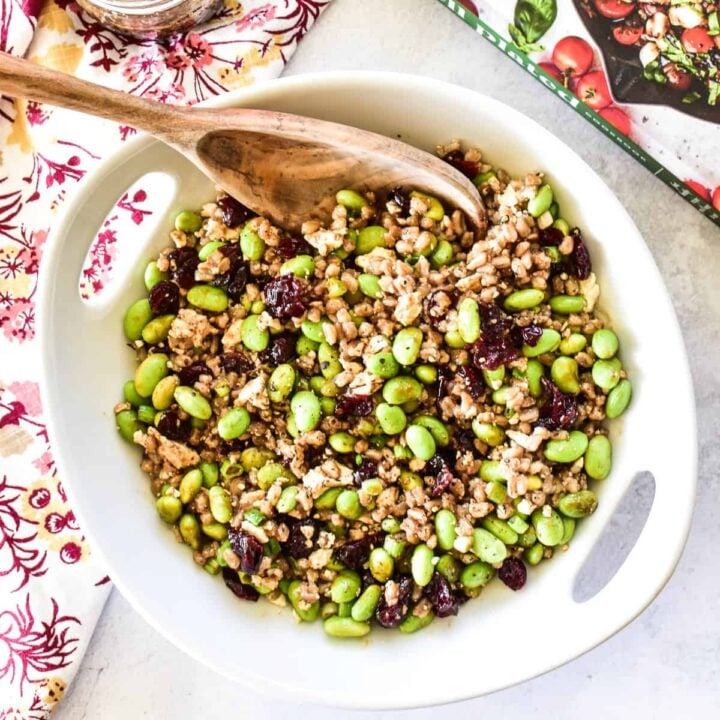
440,0 -> 720,225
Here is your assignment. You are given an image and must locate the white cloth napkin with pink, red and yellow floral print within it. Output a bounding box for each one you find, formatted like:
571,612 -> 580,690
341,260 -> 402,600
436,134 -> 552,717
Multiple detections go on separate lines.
0,0 -> 330,720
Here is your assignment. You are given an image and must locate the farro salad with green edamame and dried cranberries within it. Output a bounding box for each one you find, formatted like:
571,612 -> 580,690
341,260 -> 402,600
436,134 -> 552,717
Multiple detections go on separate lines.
115,142 -> 631,637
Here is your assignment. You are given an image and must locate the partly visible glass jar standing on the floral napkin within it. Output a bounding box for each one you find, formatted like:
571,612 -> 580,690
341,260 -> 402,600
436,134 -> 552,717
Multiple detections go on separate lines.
77,0 -> 223,39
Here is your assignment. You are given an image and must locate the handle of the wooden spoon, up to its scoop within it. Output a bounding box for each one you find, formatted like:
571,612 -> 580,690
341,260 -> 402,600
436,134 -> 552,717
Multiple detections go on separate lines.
0,52 -> 185,135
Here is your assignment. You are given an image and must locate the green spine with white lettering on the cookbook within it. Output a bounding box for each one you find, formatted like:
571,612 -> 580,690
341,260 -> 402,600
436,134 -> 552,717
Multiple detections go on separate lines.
439,0 -> 720,226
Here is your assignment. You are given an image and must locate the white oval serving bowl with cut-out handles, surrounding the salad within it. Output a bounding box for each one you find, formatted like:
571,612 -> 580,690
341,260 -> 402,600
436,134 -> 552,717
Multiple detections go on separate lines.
41,73 -> 696,708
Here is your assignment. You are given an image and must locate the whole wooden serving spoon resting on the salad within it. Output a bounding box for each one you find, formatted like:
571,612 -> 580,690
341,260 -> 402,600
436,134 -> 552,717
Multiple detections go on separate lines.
0,53 -> 485,230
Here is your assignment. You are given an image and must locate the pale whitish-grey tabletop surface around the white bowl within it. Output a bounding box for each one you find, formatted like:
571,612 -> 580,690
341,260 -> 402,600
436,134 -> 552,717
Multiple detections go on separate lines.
54,0 -> 720,720
